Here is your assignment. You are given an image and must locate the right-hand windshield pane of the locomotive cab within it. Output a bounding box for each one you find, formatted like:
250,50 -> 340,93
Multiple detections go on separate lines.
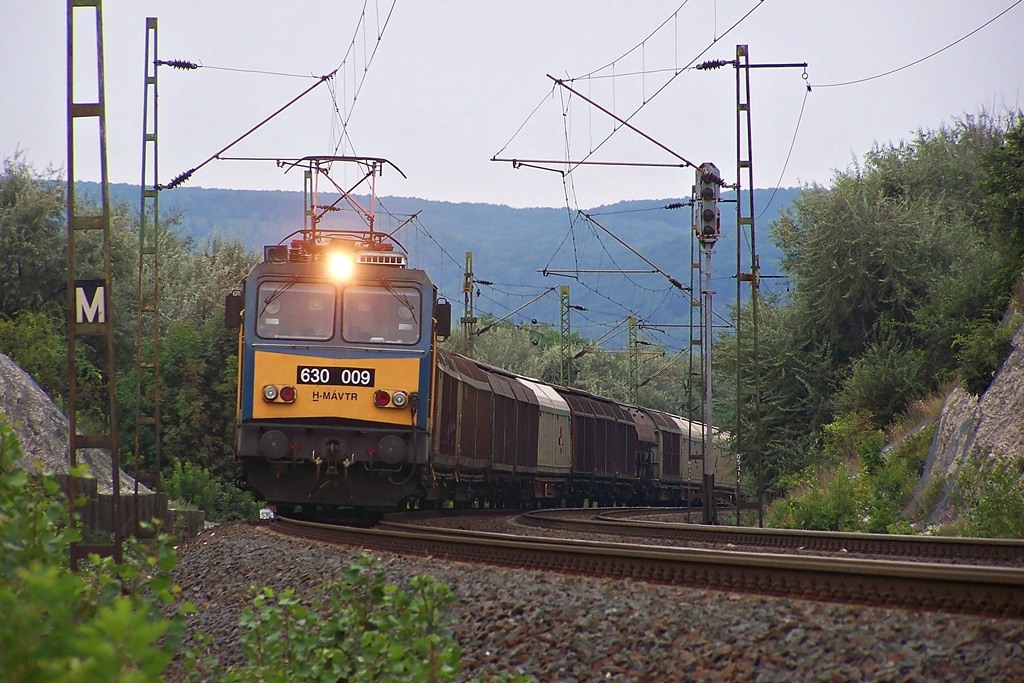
341,284 -> 422,344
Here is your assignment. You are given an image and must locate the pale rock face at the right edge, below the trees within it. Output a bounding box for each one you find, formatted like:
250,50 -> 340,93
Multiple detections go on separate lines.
918,326 -> 1024,521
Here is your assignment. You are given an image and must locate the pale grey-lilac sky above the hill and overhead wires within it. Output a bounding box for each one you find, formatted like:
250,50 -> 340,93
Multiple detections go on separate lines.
0,0 -> 1024,208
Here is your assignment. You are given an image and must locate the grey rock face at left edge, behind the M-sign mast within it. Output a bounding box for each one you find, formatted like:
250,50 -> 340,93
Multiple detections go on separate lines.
0,353 -> 152,494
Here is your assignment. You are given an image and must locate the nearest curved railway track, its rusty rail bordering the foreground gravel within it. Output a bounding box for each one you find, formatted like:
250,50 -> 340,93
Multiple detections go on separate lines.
272,511 -> 1024,617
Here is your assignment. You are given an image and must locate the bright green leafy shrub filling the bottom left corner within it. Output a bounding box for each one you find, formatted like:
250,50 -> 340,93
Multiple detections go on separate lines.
0,415 -> 190,682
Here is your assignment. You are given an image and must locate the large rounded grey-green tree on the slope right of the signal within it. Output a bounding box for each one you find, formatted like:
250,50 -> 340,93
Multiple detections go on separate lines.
772,117 -> 1005,424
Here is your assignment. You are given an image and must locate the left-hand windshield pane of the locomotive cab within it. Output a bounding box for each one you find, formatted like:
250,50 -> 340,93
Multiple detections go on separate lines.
256,281 -> 335,341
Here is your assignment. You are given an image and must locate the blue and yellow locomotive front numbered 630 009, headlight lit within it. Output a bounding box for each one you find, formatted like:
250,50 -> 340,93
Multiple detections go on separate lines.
229,238 -> 451,509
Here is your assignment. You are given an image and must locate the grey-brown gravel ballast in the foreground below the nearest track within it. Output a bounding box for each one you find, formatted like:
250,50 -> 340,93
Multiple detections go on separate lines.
171,524 -> 1024,682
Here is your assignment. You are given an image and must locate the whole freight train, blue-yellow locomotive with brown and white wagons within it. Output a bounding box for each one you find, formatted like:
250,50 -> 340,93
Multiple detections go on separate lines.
225,230 -> 736,511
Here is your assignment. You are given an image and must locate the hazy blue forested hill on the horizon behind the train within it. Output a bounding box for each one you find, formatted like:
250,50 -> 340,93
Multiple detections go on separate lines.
82,183 -> 799,331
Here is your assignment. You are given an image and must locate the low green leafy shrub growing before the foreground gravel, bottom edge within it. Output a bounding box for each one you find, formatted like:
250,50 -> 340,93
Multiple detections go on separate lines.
189,554 -> 462,683
